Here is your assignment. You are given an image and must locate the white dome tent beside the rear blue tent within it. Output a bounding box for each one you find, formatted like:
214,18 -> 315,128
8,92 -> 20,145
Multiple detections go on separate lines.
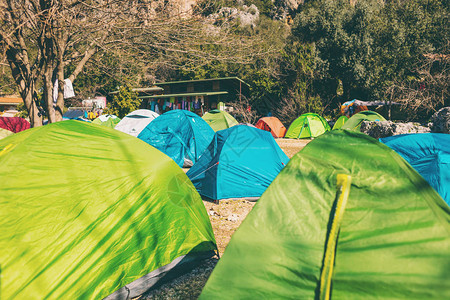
114,109 -> 159,137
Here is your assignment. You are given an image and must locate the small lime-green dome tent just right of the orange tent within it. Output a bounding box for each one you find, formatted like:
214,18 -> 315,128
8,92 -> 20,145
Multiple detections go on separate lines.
285,113 -> 331,139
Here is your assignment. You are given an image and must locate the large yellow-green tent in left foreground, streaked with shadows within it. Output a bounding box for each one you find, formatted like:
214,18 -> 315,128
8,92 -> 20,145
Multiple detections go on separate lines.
0,120 -> 216,299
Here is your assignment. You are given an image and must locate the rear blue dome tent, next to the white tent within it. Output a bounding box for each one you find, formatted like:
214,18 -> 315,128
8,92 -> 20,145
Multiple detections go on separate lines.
138,109 -> 214,167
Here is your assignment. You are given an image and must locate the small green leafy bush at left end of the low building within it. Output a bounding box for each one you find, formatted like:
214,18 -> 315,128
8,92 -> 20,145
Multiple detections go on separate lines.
108,84 -> 142,118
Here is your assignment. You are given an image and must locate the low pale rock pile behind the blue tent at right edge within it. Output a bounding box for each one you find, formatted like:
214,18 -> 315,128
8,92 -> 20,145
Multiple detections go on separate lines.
361,121 -> 431,139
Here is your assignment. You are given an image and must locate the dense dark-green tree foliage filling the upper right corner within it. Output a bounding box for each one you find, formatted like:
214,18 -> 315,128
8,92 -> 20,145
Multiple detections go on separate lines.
293,0 -> 449,119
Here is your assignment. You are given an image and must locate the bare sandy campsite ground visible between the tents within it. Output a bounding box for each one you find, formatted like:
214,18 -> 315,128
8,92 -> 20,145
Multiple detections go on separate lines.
140,139 -> 310,299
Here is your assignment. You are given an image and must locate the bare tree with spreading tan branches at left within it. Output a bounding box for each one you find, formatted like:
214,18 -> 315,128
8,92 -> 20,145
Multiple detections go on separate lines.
0,0 -> 256,126
